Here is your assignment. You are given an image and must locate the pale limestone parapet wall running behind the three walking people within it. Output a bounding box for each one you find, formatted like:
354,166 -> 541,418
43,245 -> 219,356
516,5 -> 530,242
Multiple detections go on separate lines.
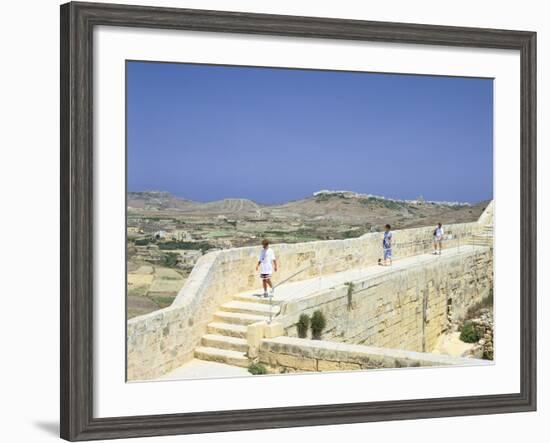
127,204 -> 492,380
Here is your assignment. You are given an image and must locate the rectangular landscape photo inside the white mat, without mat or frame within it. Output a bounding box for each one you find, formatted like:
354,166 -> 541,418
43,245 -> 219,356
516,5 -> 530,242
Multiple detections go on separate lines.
127,60 -> 498,382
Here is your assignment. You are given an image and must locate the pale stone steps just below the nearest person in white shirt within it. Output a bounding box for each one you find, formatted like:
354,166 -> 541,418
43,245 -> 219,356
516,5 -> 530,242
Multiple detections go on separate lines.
195,295 -> 281,368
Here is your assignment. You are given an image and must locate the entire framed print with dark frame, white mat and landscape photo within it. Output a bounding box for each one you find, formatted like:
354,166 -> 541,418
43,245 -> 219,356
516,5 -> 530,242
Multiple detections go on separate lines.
61,3 -> 536,441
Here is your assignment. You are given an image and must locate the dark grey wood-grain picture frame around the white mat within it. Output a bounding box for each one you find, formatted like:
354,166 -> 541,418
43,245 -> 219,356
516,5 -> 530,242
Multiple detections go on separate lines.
60,3 -> 536,441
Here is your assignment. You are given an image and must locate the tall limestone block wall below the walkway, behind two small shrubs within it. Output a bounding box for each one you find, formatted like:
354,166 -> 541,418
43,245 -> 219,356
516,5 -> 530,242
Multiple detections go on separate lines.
277,250 -> 493,352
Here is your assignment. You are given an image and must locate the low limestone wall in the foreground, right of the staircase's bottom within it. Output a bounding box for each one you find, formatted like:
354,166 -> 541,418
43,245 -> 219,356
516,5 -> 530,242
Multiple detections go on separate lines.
258,337 -> 490,371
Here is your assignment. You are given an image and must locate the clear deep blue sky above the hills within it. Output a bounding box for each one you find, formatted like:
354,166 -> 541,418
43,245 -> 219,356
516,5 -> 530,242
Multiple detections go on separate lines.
127,62 -> 493,203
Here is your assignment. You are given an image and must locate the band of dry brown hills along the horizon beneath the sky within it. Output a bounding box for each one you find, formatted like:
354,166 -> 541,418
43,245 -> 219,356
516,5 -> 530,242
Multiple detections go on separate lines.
128,191 -> 488,228
